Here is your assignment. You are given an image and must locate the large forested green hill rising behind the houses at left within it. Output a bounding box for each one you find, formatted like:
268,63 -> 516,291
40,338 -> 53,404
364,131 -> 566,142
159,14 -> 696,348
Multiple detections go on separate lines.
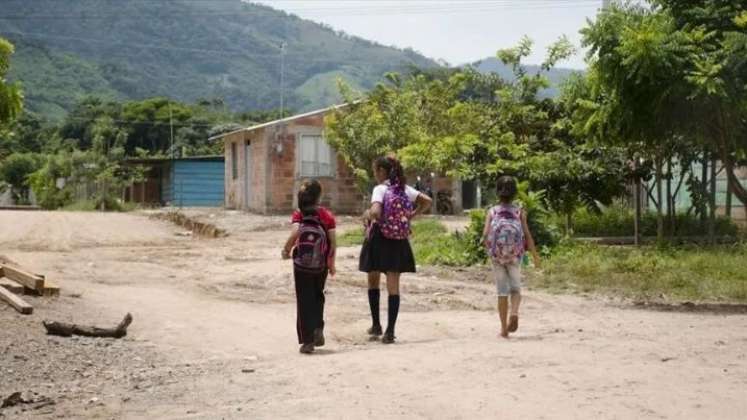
0,0 -> 436,117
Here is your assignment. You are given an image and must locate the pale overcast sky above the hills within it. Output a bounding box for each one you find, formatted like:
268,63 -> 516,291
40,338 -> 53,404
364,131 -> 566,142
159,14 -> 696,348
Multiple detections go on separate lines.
253,0 -> 602,68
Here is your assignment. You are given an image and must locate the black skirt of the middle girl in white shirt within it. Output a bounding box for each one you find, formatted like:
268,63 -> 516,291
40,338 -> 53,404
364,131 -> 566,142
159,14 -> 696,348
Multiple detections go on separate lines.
358,225 -> 415,273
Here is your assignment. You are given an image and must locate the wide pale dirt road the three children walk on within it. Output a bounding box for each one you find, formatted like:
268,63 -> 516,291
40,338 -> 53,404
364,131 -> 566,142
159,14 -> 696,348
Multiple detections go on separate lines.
0,212 -> 747,419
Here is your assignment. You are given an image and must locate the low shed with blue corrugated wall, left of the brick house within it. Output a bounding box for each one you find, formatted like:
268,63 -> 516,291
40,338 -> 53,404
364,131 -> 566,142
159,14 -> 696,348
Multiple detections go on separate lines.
125,156 -> 225,207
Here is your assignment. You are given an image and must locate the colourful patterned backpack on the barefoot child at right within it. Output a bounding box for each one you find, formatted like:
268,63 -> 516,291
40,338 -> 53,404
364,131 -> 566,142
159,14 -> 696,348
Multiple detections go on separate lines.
488,204 -> 524,264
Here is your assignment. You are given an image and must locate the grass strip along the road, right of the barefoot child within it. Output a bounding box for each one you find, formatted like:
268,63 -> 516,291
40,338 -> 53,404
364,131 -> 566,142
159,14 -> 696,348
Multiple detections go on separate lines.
534,244 -> 747,302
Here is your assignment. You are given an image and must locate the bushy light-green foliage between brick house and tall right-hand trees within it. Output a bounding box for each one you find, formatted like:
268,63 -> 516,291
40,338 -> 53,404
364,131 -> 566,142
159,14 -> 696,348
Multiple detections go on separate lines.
327,38 -> 627,223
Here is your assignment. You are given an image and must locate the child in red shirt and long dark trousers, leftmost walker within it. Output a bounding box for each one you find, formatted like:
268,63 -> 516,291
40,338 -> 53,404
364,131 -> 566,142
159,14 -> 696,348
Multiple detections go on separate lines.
282,180 -> 337,354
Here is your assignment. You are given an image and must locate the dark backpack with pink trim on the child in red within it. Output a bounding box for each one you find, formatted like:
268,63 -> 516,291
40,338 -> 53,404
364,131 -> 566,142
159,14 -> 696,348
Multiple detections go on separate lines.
293,216 -> 329,273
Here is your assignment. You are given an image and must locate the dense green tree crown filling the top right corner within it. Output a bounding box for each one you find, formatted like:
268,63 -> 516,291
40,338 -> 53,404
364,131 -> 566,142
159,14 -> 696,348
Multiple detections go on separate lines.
576,0 -> 747,217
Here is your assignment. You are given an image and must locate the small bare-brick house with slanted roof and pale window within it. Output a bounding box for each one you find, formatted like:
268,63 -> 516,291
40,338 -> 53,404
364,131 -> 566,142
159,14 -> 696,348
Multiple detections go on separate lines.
210,107 -> 470,214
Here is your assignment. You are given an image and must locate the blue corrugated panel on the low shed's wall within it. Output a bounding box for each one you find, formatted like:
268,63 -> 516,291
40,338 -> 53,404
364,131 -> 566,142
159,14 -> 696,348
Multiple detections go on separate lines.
171,160 -> 225,207
